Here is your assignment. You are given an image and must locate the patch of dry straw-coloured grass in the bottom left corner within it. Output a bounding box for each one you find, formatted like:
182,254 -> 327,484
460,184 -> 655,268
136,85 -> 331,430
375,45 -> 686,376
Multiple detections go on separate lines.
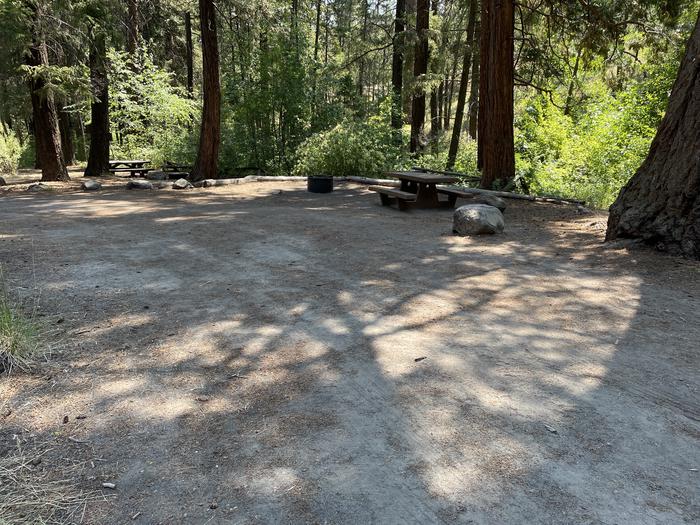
0,436 -> 104,525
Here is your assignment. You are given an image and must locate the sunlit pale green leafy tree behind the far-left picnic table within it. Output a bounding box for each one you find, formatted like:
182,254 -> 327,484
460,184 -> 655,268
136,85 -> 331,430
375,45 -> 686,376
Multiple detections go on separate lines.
108,49 -> 199,165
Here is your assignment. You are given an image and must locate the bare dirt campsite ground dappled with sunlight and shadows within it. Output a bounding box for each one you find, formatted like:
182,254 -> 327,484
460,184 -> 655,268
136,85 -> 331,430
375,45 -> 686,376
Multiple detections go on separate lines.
0,174 -> 700,524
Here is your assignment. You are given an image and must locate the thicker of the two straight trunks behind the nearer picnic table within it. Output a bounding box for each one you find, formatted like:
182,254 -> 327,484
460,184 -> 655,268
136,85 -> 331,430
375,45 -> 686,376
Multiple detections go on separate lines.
411,0 -> 430,153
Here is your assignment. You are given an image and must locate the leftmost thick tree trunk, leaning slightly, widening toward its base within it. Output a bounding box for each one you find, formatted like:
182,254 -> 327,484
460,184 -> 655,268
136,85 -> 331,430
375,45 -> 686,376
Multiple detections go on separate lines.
28,36 -> 70,181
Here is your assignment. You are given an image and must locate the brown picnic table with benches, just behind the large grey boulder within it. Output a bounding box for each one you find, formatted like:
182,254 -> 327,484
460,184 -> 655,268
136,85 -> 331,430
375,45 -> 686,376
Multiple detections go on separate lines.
369,171 -> 458,210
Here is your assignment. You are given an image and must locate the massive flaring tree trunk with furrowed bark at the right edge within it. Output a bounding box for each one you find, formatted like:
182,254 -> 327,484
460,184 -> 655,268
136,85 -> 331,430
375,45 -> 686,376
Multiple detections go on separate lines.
606,18 -> 700,258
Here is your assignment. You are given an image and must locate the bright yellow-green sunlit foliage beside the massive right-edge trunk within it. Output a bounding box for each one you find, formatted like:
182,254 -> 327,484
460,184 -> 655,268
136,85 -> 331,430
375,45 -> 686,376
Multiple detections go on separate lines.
515,41 -> 678,208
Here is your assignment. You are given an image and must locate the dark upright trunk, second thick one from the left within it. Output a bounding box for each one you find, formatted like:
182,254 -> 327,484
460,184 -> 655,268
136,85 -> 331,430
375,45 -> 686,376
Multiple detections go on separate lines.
84,34 -> 111,177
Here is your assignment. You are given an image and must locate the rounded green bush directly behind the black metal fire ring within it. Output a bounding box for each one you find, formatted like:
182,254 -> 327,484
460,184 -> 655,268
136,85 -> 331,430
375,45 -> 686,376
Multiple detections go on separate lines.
294,116 -> 401,177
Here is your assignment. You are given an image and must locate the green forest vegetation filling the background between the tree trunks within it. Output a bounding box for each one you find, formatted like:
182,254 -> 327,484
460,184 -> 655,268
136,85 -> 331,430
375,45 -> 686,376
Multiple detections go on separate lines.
0,0 -> 700,207
